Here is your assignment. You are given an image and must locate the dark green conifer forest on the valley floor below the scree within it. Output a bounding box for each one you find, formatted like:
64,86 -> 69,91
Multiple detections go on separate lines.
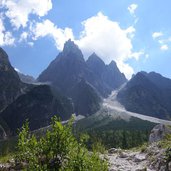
77,118 -> 155,149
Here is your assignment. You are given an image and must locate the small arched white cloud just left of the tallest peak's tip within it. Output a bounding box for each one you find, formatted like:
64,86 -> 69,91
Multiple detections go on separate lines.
31,20 -> 74,50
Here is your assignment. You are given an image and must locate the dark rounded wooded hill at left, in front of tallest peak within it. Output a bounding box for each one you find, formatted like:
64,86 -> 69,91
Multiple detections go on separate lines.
0,85 -> 73,134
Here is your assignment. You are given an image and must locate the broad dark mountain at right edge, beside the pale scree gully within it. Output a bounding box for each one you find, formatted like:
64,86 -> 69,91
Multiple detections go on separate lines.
117,72 -> 171,119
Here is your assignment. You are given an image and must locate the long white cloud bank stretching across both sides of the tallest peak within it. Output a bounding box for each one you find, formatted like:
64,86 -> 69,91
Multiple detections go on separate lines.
30,12 -> 144,79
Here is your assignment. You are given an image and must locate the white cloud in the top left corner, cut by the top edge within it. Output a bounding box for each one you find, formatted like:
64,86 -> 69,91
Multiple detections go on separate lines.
1,0 -> 52,29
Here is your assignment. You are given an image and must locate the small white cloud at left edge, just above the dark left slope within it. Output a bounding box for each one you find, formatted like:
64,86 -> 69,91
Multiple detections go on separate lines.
0,15 -> 15,46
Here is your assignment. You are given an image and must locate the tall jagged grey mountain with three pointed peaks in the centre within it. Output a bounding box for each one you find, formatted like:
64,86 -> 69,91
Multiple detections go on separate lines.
38,40 -> 126,115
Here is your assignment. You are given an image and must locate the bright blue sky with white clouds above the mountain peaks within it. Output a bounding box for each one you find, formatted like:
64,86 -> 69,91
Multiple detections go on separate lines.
0,0 -> 171,78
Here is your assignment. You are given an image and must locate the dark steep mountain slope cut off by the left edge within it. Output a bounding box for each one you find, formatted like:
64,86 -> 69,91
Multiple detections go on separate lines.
0,48 -> 24,111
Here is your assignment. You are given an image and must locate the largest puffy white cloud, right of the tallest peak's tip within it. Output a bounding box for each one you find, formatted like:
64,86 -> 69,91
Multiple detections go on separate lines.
76,12 -> 140,78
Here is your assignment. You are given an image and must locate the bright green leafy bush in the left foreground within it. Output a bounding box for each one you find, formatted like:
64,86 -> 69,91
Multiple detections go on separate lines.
16,117 -> 108,171
